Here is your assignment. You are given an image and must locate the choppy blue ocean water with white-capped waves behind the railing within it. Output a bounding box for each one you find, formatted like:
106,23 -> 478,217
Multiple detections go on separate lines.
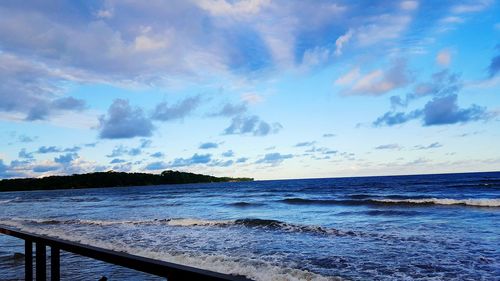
0,173 -> 500,280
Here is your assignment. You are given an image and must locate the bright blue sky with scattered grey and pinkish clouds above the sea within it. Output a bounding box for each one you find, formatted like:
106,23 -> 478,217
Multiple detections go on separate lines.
0,0 -> 500,179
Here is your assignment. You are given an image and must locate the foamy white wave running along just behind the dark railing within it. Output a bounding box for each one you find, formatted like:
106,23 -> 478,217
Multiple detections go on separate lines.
0,221 -> 343,281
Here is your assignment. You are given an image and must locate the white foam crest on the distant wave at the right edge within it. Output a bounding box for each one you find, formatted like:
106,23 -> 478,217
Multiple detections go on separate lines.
372,198 -> 500,207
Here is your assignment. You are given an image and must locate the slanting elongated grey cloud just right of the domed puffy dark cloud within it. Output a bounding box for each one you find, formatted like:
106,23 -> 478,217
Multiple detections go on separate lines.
152,96 -> 201,121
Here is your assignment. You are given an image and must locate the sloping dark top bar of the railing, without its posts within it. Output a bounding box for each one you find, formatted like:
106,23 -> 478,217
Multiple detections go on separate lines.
0,226 -> 250,281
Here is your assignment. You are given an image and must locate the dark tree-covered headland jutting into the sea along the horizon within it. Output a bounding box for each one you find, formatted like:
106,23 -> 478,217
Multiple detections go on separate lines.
0,170 -> 253,192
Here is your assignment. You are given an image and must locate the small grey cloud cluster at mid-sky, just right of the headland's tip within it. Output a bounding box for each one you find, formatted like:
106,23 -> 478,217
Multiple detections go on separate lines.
224,115 -> 283,136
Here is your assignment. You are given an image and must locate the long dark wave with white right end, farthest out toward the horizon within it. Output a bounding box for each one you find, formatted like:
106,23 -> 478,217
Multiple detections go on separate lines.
279,196 -> 500,207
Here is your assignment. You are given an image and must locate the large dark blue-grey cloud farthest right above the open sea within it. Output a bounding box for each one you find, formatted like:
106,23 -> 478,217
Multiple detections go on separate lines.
424,95 -> 489,126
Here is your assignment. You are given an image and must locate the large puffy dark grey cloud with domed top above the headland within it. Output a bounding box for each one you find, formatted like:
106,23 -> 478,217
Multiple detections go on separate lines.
99,99 -> 154,139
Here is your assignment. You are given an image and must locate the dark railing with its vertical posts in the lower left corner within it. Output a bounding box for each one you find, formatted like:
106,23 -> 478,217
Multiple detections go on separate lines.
0,226 -> 250,281
